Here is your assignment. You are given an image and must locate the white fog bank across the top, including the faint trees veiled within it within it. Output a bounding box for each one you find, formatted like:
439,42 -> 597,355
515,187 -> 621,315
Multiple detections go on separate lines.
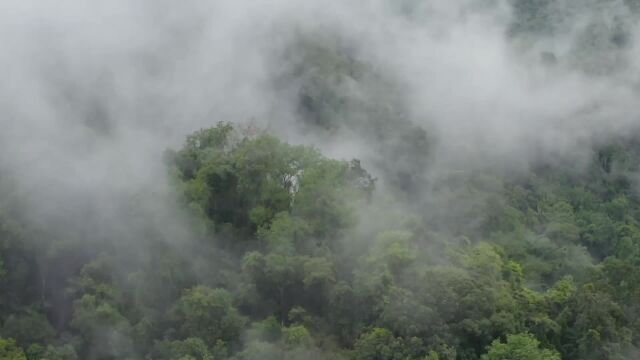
0,0 -> 640,358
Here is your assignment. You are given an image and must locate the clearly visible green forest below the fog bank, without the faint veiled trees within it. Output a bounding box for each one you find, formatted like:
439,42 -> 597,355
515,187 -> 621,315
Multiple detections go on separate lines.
0,123 -> 640,360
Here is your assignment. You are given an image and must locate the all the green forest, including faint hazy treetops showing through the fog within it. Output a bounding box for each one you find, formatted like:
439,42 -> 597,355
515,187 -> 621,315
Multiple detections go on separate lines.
0,0 -> 640,360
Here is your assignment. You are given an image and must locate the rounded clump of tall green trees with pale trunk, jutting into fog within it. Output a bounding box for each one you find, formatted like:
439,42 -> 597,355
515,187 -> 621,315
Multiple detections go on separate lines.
170,123 -> 373,236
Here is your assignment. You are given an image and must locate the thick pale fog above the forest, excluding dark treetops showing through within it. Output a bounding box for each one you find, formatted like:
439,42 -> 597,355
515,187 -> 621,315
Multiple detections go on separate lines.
0,0 -> 640,245
